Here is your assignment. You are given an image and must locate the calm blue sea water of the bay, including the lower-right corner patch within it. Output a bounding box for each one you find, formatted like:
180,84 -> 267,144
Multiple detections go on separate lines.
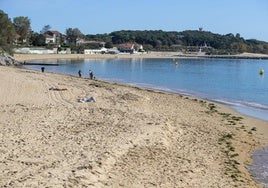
26,58 -> 268,185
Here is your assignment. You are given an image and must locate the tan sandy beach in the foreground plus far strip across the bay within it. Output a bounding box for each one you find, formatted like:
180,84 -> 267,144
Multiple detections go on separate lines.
0,54 -> 268,188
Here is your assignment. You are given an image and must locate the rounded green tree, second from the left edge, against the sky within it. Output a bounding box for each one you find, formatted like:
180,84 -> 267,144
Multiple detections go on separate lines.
13,16 -> 31,43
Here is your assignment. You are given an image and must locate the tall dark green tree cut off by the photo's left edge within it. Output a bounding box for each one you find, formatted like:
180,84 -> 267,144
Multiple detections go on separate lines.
0,10 -> 16,54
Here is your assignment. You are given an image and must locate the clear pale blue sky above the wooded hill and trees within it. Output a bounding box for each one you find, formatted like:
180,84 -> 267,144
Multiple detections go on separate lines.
0,0 -> 268,42
